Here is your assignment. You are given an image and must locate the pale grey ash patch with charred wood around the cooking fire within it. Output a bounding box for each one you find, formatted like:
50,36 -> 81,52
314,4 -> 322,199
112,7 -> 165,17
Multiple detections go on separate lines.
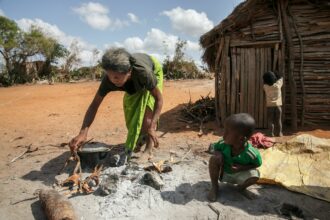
52,142 -> 211,219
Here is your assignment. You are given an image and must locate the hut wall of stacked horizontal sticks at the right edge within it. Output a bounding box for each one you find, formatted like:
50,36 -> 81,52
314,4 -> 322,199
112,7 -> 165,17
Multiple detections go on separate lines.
286,1 -> 330,125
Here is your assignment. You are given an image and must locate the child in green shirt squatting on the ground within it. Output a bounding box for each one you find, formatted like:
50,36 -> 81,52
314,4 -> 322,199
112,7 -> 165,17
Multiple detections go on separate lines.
208,113 -> 262,202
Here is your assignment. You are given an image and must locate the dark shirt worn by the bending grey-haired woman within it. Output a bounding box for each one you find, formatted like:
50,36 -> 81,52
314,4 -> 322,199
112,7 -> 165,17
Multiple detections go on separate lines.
98,53 -> 157,97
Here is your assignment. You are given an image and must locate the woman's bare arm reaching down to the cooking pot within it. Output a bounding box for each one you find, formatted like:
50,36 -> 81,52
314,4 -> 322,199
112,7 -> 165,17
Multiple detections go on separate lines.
69,93 -> 103,151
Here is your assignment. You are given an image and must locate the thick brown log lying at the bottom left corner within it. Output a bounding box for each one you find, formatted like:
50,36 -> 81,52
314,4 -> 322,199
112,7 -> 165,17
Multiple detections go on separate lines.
39,190 -> 78,220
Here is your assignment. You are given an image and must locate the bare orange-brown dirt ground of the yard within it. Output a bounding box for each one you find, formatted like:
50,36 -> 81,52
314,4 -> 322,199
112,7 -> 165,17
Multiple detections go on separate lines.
0,80 -> 330,220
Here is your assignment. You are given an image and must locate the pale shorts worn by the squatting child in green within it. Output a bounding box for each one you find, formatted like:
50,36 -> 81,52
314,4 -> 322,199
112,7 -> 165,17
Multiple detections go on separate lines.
220,169 -> 260,185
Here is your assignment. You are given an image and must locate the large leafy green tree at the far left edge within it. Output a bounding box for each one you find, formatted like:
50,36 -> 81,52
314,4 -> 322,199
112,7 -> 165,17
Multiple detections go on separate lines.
0,16 -> 68,85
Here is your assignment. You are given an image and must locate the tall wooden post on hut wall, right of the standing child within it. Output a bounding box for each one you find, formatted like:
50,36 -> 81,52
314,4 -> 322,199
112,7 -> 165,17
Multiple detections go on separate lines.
279,0 -> 297,131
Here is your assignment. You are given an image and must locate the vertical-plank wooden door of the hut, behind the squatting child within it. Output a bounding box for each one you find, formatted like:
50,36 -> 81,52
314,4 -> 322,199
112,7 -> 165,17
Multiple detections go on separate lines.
227,47 -> 273,128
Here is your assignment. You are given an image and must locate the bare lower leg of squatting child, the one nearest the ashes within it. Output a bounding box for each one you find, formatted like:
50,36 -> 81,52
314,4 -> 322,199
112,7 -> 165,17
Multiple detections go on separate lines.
208,152 -> 223,202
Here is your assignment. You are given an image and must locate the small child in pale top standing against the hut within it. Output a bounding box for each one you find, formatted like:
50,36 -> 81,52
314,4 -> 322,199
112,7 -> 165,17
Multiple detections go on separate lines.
263,71 -> 283,137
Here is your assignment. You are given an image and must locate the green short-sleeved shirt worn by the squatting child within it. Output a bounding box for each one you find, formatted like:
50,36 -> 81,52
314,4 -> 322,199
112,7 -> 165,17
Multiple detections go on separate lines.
213,140 -> 262,173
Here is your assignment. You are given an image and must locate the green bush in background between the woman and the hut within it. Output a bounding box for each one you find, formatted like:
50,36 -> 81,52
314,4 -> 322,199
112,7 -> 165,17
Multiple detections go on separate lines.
163,39 -> 209,79
